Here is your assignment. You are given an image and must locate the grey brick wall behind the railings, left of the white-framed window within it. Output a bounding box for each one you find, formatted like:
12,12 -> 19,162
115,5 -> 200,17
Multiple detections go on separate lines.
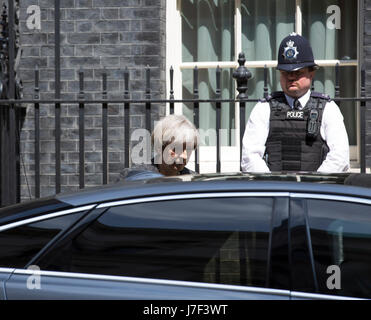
19,0 -> 166,199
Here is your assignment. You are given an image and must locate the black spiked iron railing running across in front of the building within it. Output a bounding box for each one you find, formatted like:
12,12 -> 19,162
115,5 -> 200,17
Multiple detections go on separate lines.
0,55 -> 371,206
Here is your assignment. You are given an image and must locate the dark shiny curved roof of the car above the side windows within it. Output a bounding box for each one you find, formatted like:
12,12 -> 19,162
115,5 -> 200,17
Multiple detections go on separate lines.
0,172 -> 371,225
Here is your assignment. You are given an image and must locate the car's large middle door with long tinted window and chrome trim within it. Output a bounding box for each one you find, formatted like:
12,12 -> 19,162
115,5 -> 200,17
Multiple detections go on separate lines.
6,192 -> 290,300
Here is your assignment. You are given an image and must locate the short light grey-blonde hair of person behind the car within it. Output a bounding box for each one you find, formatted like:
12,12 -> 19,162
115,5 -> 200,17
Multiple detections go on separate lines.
151,114 -> 199,155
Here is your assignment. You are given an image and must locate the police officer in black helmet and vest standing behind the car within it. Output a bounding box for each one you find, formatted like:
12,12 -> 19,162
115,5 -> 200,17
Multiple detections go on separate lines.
241,33 -> 349,173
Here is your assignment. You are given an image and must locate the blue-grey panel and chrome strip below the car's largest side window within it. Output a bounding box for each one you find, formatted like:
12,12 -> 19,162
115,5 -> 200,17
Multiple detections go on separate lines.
5,269 -> 290,300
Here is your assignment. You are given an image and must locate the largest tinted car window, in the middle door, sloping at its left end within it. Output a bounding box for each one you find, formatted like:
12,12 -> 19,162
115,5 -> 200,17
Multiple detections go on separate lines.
41,198 -> 274,286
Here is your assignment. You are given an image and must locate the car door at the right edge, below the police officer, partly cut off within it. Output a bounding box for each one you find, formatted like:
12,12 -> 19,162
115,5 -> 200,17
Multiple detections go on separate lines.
290,194 -> 371,299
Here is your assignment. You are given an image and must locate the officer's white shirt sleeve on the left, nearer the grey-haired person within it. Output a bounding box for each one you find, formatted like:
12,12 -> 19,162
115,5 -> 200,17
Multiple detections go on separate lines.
241,102 -> 270,172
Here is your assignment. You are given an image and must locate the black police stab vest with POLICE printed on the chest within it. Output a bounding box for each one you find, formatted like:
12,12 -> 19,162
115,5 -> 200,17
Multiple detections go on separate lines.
264,91 -> 330,171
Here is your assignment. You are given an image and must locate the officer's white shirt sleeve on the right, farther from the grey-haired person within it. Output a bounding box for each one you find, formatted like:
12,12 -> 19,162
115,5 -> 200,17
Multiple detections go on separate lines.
317,101 -> 349,173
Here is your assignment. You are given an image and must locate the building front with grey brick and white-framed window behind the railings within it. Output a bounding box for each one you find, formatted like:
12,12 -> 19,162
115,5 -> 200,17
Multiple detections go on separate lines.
12,0 -> 371,199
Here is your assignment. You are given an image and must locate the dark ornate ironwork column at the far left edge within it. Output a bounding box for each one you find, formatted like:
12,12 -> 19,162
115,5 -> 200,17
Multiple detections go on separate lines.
0,0 -> 22,204
